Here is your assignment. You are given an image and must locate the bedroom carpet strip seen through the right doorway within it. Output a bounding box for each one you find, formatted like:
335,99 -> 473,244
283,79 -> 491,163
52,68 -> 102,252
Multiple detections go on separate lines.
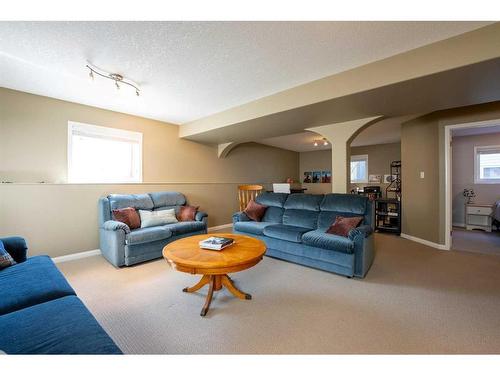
452,227 -> 500,255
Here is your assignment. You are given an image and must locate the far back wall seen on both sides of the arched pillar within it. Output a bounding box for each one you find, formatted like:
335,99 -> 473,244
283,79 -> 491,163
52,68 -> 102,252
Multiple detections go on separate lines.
300,143 -> 401,194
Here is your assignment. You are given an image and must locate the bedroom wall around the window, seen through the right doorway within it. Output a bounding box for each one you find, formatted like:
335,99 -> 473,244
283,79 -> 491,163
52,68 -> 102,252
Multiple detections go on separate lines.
451,133 -> 500,225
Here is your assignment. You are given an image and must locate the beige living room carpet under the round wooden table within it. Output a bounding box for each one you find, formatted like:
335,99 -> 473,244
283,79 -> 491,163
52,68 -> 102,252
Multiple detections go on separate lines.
56,235 -> 500,354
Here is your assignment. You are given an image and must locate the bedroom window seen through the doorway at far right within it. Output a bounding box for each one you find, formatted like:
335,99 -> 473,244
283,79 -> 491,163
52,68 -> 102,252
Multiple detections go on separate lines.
474,146 -> 500,184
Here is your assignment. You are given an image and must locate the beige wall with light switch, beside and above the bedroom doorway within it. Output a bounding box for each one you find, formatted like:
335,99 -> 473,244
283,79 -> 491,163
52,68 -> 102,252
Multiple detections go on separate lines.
401,101 -> 500,244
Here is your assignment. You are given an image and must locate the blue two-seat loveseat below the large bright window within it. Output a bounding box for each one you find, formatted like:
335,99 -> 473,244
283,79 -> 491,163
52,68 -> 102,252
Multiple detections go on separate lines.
98,191 -> 207,267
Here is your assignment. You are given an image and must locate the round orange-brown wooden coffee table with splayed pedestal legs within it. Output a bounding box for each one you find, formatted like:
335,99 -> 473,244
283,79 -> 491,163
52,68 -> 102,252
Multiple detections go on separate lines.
163,233 -> 266,316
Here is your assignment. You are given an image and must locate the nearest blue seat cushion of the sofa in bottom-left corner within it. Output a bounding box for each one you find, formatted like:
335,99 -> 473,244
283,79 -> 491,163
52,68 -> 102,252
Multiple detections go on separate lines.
0,296 -> 122,354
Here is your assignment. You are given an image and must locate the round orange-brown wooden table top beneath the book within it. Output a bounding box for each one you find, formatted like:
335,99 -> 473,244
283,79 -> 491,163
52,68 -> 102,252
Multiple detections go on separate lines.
163,233 -> 266,274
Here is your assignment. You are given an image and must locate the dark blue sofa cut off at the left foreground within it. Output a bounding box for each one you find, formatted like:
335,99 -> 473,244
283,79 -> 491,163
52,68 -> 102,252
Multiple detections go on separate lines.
0,237 -> 122,354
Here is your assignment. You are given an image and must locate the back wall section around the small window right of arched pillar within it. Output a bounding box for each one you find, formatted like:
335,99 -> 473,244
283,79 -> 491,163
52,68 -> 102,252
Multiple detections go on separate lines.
350,142 -> 401,197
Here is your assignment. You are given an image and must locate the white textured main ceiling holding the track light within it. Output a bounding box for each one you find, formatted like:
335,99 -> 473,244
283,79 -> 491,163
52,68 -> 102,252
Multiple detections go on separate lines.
0,22 -> 488,123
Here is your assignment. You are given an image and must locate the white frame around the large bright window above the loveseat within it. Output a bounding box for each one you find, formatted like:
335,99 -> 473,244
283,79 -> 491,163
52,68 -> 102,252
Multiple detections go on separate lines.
67,121 -> 143,184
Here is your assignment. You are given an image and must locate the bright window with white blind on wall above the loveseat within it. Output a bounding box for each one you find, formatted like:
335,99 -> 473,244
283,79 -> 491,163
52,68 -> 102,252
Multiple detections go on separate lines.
68,121 -> 142,183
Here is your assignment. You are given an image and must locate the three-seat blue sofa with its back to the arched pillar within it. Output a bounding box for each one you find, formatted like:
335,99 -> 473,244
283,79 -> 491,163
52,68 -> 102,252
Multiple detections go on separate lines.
233,193 -> 374,278
